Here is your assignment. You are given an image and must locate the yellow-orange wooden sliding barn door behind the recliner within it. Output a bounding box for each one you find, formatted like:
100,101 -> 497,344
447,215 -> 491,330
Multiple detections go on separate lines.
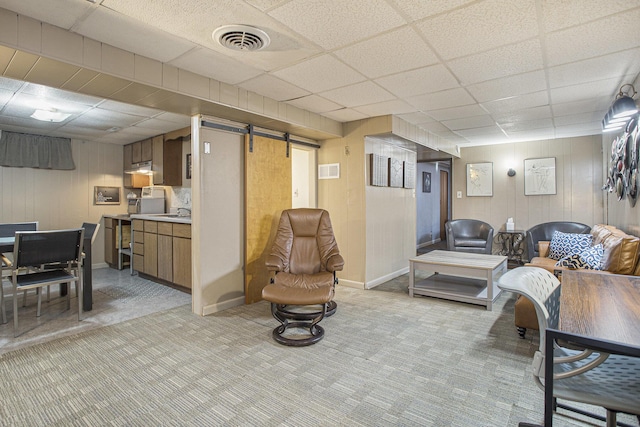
245,135 -> 291,304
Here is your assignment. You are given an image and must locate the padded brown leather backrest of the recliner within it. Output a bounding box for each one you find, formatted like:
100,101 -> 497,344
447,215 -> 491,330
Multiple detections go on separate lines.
271,208 -> 339,274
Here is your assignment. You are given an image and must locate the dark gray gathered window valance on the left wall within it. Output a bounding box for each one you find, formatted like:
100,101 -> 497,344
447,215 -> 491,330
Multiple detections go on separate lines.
0,131 -> 76,170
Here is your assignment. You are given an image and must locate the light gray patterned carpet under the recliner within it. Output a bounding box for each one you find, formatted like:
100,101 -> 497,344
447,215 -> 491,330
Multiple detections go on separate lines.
0,276 -> 636,427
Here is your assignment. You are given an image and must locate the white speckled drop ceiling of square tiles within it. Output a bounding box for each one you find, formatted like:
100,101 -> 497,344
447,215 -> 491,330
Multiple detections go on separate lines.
0,0 -> 640,147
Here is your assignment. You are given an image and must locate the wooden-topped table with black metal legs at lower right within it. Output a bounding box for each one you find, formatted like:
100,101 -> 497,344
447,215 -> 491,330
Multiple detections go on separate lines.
540,270 -> 640,427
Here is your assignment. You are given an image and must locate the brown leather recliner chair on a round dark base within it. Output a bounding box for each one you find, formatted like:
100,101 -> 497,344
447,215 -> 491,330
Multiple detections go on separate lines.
262,208 -> 344,346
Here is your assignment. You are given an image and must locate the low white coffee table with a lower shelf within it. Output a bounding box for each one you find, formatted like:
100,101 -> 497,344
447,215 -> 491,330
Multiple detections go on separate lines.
409,251 -> 507,311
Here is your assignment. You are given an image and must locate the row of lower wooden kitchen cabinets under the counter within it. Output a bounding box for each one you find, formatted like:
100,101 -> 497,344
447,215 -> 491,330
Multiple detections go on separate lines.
133,219 -> 191,289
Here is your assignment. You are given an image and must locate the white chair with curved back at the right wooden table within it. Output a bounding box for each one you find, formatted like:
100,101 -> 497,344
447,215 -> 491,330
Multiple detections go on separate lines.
498,267 -> 640,427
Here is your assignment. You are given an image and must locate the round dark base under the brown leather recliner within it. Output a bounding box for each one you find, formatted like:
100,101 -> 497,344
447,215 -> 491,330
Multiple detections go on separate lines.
271,303 -> 328,347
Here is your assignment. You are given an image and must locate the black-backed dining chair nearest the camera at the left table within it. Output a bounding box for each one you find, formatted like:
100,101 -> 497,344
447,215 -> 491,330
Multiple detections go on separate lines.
3,228 -> 84,336
